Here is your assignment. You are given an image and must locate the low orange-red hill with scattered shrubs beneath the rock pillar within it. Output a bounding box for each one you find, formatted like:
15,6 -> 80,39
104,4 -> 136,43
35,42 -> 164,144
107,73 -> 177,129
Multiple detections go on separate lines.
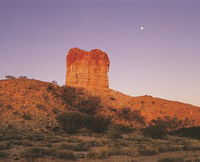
0,79 -> 200,129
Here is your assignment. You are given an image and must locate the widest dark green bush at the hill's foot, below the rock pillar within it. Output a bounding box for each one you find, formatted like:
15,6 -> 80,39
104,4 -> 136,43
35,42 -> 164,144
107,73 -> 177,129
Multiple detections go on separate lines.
56,112 -> 111,133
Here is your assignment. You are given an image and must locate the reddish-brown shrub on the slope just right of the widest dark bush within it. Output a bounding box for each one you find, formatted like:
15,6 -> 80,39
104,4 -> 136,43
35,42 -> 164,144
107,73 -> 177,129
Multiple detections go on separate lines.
117,107 -> 145,124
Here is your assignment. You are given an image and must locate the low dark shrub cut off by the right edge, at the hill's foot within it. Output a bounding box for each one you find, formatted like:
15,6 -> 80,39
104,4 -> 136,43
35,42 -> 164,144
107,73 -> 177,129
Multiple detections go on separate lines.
175,127 -> 200,139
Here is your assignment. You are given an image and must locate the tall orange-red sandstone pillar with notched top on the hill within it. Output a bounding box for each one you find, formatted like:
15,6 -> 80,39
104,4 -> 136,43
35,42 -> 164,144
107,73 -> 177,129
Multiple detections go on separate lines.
66,48 -> 110,89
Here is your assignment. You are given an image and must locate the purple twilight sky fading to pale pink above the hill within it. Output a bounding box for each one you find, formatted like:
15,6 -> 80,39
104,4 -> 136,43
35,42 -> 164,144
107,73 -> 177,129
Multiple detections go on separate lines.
0,0 -> 200,106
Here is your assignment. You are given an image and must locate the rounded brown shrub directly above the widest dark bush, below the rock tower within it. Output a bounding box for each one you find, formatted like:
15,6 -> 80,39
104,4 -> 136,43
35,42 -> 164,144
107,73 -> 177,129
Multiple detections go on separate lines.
74,96 -> 102,115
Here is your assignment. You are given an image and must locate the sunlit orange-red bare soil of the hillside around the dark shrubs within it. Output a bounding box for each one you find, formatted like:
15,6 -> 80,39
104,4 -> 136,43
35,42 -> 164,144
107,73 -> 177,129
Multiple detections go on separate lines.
0,79 -> 200,128
